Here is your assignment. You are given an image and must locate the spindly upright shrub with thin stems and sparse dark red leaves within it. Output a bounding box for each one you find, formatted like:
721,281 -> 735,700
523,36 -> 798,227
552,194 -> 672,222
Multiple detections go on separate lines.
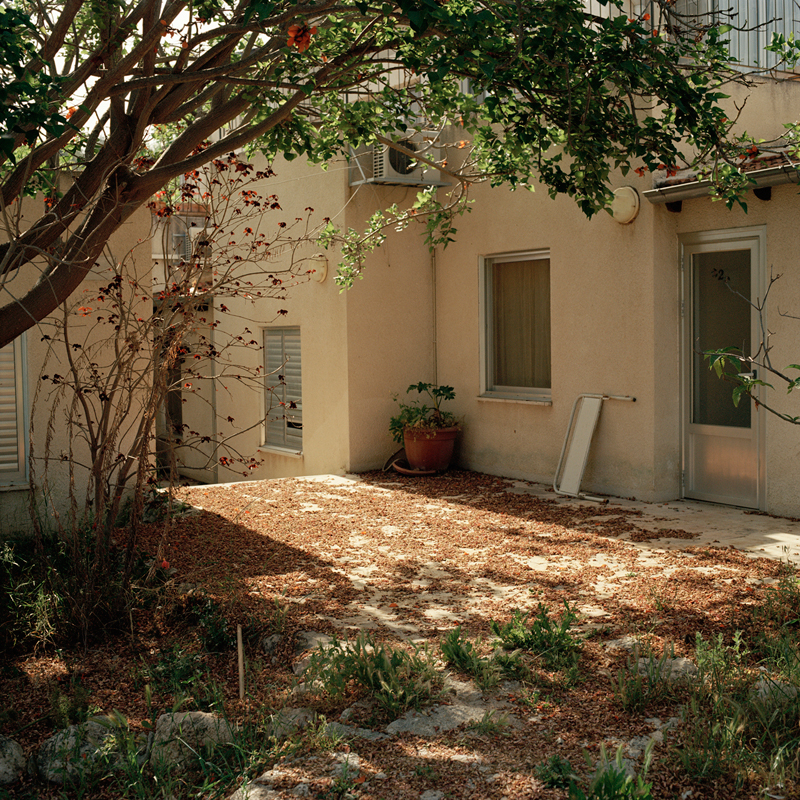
29,155 -> 315,642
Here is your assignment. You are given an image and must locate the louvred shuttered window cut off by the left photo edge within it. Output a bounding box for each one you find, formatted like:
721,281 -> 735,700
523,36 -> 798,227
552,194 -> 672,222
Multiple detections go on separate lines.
0,338 -> 27,485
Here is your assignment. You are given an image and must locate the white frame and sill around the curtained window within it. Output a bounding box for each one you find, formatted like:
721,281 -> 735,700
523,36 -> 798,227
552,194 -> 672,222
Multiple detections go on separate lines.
480,249 -> 552,405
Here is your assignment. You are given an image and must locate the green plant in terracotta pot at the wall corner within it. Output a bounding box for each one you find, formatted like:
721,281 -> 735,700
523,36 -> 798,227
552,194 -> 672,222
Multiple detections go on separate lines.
389,382 -> 461,472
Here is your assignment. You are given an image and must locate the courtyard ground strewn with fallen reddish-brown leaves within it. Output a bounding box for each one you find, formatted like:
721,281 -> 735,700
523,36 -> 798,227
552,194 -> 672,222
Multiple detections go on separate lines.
0,471 -> 788,800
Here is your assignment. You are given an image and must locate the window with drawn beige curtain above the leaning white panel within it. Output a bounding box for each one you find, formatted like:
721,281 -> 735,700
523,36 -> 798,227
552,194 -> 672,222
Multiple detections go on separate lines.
483,251 -> 551,400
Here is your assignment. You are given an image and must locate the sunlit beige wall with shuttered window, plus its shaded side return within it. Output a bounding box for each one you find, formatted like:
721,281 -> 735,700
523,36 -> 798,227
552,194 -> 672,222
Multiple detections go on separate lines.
200,153 -> 435,481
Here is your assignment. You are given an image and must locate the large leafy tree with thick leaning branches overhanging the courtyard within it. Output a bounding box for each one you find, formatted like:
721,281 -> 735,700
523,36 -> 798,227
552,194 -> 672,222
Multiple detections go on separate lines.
0,0 -> 731,346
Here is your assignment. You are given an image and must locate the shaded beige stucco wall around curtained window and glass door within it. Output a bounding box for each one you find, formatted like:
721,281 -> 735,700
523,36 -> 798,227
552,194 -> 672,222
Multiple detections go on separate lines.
322,72 -> 797,509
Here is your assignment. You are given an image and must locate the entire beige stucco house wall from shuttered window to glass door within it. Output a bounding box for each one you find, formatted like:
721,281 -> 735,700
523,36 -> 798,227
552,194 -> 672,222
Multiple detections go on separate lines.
173,72 -> 800,513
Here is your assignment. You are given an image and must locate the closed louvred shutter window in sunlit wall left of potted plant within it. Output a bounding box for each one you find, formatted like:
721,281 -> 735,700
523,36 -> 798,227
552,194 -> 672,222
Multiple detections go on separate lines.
264,328 -> 303,453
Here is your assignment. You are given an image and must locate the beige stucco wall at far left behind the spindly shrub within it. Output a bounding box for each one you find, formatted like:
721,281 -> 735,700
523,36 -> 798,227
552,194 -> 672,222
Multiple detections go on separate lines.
0,199 -> 151,531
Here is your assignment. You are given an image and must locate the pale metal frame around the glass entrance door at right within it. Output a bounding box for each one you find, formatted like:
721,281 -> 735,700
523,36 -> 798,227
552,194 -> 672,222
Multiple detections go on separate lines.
678,225 -> 767,511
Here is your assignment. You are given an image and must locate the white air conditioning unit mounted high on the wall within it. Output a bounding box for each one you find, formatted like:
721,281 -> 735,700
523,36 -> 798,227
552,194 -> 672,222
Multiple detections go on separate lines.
350,131 -> 448,187
